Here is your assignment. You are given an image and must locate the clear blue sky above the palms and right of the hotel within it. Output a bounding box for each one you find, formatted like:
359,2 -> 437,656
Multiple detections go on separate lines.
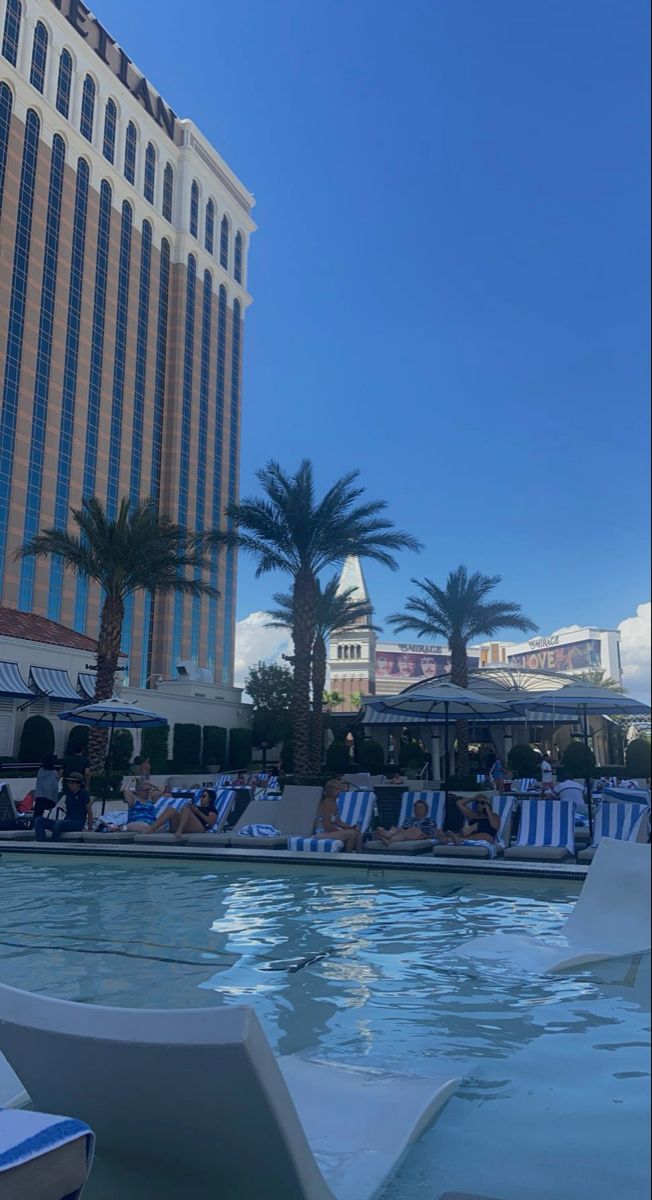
104,0 -> 650,667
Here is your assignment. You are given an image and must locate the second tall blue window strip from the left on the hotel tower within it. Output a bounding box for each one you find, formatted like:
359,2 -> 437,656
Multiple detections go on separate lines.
0,108 -> 41,592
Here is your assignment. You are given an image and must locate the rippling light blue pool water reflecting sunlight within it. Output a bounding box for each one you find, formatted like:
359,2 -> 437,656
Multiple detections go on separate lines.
0,856 -> 650,1200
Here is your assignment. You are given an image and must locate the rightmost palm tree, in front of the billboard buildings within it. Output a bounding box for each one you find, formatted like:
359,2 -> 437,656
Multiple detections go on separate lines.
388,566 -> 537,775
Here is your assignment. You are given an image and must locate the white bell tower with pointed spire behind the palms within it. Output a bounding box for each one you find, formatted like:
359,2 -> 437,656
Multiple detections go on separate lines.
328,554 -> 376,710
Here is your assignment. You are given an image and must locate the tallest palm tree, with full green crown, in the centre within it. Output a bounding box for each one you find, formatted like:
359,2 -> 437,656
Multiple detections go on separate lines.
204,458 -> 419,774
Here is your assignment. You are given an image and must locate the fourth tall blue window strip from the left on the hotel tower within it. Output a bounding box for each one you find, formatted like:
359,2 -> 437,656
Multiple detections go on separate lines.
48,158 -> 90,620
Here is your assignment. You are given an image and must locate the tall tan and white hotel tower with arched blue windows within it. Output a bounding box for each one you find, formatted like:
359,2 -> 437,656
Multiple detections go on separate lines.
0,0 -> 255,686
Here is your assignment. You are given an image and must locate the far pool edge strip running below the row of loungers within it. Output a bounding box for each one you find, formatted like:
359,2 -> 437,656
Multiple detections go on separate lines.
0,840 -> 588,883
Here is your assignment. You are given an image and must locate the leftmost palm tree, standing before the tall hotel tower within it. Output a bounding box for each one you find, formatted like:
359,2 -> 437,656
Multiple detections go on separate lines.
16,497 -> 217,770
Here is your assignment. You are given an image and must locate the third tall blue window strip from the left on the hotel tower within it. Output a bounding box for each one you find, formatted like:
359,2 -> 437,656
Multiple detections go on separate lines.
18,133 -> 66,612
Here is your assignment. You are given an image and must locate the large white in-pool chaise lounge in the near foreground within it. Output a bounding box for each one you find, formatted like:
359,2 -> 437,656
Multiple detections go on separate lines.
0,985 -> 457,1200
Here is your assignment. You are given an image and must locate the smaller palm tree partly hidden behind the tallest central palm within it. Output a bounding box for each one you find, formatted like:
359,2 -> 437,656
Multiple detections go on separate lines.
269,576 -> 377,772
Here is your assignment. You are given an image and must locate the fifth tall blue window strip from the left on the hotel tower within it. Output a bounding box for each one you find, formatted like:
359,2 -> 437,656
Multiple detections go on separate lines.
73,179 -> 113,631
